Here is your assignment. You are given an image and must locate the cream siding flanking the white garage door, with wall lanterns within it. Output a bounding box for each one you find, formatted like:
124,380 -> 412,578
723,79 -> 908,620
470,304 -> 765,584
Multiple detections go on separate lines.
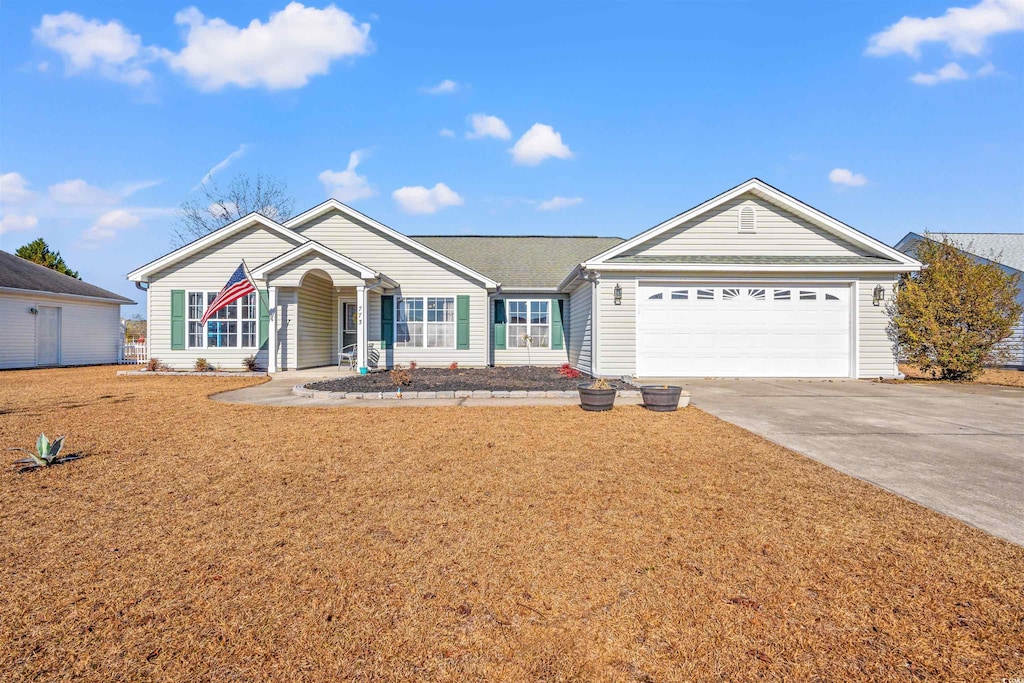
595,272 -> 897,378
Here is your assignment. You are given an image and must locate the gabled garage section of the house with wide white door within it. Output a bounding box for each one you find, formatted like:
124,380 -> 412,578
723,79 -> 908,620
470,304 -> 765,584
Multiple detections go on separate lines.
562,178 -> 921,381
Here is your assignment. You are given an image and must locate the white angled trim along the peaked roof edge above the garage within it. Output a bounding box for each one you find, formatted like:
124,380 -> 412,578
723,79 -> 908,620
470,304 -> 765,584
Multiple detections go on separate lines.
584,178 -> 921,270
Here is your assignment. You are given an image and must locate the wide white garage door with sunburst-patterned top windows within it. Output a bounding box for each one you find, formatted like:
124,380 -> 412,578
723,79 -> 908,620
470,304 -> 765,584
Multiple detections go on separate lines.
637,284 -> 851,377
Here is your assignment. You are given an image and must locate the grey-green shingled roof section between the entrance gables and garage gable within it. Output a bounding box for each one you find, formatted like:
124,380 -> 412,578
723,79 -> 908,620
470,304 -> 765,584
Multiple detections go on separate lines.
413,234 -> 623,290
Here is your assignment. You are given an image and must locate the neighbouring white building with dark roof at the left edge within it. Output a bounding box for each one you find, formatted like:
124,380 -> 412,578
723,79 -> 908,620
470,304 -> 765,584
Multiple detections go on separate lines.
0,251 -> 135,369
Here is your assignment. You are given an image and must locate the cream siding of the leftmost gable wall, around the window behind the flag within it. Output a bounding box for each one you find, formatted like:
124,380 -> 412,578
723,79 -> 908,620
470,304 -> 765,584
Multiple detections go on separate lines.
147,225 -> 300,370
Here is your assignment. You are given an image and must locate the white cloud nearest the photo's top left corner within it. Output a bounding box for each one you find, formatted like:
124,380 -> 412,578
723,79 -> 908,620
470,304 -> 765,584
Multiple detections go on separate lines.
33,12 -> 162,85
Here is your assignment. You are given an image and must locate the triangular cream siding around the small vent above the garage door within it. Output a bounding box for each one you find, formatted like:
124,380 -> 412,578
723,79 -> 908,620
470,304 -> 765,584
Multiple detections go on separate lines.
622,193 -> 867,256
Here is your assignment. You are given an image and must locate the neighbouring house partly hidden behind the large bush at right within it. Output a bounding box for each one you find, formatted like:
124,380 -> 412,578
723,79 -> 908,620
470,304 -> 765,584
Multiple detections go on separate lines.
896,232 -> 1024,368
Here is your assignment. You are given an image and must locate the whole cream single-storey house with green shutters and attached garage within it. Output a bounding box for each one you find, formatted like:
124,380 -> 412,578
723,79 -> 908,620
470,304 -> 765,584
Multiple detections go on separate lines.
128,178 -> 921,377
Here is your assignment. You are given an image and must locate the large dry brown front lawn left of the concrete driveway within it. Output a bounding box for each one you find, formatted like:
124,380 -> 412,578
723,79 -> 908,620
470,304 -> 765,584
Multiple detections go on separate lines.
0,368 -> 1024,681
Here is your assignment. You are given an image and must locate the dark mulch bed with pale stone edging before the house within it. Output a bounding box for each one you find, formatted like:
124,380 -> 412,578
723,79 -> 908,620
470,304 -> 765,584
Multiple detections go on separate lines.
307,366 -> 590,392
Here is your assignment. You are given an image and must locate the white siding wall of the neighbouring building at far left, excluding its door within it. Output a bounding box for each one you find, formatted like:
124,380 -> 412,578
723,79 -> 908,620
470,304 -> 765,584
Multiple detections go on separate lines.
0,293 -> 122,369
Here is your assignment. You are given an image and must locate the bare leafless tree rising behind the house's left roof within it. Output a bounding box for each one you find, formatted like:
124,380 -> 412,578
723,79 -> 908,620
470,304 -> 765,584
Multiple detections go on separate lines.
172,173 -> 295,247
